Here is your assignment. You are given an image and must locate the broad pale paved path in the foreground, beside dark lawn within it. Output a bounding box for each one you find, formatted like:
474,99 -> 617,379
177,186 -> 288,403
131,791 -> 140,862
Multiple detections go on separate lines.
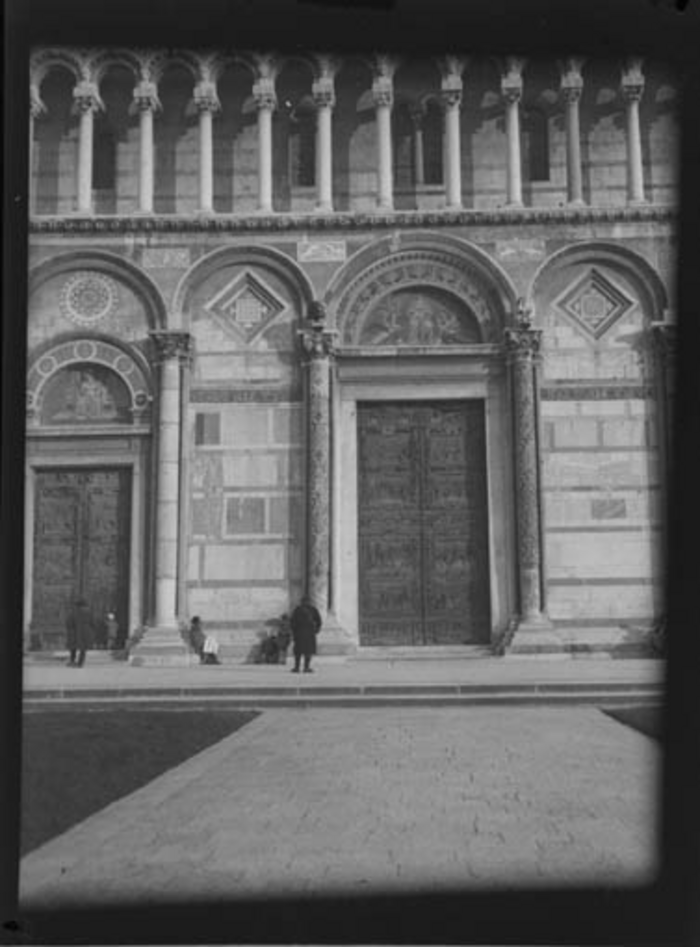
21,707 -> 659,910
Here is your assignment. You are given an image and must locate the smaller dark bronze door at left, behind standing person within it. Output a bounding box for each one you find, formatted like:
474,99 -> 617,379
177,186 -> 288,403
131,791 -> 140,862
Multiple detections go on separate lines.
32,467 -> 131,648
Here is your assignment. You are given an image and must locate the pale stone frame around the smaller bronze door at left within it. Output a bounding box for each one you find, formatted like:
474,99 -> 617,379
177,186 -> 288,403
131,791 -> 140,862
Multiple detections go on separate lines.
23,435 -> 148,651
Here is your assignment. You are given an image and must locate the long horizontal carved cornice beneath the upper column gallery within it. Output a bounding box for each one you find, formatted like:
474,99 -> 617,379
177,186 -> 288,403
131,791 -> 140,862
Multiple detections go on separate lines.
29,204 -> 677,234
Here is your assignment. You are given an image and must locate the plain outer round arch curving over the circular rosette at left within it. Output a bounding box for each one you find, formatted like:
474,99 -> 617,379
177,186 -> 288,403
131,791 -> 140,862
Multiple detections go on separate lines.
29,250 -> 167,329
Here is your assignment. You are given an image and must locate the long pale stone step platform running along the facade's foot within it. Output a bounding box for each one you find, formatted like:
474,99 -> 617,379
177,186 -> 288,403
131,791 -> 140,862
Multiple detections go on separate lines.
24,658 -> 664,706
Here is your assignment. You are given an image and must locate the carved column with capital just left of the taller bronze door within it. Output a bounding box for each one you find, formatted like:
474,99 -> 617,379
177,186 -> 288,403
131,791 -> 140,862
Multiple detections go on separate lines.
299,302 -> 335,616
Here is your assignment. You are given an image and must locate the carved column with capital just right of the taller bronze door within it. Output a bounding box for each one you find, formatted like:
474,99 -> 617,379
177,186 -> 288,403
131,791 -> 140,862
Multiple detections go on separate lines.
505,309 -> 548,626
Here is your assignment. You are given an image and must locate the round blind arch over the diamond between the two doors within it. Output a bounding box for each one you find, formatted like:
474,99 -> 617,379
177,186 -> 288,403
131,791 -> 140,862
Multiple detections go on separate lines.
173,247 -> 314,324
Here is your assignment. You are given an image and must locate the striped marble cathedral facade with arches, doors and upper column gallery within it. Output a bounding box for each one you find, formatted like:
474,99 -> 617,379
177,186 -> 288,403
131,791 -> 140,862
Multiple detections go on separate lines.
24,48 -> 679,663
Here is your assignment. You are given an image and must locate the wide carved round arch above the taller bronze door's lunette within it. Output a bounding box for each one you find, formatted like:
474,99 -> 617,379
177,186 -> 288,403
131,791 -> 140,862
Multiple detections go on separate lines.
324,231 -> 516,343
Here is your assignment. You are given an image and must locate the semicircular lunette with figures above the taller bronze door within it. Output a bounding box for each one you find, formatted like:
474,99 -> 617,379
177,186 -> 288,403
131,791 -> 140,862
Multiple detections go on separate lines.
358,290 -> 481,346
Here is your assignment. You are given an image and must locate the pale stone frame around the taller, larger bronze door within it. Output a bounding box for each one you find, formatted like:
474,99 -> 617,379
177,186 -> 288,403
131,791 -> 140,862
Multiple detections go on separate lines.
331,345 -> 516,648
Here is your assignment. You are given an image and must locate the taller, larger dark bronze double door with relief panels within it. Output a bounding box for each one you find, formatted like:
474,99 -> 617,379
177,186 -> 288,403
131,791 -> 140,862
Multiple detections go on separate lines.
358,401 -> 490,646
